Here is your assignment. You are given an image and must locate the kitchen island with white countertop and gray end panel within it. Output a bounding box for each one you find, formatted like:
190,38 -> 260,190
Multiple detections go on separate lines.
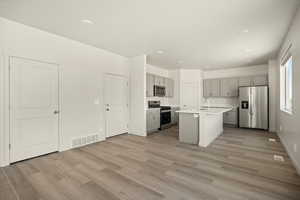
177,108 -> 232,147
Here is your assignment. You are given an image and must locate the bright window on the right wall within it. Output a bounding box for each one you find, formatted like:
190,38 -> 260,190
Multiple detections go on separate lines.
280,54 -> 293,114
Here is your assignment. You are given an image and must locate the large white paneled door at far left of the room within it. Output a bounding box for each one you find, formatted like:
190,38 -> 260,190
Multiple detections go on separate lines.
10,57 -> 59,162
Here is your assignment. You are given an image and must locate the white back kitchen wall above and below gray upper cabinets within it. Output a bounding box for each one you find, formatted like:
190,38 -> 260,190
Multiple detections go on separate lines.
203,64 -> 269,105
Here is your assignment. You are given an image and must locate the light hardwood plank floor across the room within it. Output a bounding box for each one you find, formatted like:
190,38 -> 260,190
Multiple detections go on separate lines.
0,127 -> 300,200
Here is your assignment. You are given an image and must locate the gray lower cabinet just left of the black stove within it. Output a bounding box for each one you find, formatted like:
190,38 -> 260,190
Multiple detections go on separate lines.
146,108 -> 160,133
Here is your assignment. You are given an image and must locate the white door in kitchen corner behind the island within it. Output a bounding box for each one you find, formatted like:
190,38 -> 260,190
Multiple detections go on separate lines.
180,82 -> 199,109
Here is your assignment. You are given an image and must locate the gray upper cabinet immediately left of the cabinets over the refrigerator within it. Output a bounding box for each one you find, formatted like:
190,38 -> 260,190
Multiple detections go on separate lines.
221,78 -> 239,97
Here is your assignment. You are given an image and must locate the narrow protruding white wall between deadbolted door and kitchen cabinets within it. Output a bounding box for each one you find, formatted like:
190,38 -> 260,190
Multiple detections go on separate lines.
129,55 -> 147,136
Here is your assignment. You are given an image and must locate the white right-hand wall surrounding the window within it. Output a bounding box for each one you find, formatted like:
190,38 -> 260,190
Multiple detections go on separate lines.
277,10 -> 300,174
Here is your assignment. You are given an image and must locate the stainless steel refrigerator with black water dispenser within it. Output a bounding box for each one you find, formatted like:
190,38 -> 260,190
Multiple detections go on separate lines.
239,86 -> 269,130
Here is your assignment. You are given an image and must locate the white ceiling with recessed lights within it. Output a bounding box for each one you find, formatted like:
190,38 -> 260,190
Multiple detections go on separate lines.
0,0 -> 299,69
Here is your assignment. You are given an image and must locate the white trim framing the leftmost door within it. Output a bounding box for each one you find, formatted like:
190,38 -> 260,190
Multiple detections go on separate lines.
0,52 -> 62,166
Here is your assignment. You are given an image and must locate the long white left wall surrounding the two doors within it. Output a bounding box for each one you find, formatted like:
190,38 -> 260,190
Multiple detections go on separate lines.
0,18 -> 129,165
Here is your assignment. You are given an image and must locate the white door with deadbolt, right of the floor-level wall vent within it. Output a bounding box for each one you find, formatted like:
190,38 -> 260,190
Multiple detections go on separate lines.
105,74 -> 128,137
